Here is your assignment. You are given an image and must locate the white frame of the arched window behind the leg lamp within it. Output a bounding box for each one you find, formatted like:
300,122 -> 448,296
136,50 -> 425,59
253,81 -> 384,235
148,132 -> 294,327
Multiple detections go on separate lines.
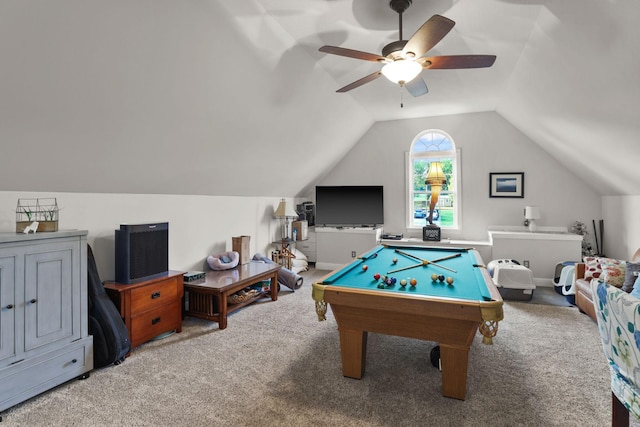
405,129 -> 462,231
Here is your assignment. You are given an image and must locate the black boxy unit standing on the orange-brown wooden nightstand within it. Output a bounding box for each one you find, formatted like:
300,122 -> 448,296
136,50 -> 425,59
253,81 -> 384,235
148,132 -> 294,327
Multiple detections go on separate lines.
115,222 -> 169,284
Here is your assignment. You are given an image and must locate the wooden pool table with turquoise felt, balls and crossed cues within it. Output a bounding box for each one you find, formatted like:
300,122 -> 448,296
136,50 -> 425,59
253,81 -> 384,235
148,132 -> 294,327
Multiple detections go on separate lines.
312,245 -> 503,400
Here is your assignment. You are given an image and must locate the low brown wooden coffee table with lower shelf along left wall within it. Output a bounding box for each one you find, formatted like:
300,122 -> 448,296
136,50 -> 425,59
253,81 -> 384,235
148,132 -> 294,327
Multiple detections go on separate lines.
184,261 -> 282,329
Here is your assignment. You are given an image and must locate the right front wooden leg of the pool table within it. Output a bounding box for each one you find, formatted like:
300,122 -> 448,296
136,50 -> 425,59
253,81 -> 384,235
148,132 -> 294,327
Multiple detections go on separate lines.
440,343 -> 469,400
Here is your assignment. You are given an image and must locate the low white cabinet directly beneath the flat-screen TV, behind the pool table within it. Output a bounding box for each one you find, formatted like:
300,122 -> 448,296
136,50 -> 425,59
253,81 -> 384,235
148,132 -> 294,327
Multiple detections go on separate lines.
316,227 -> 382,270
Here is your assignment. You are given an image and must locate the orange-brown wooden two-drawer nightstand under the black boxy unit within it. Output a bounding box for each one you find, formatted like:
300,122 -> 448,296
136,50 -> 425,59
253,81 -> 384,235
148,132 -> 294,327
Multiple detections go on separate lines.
104,271 -> 184,349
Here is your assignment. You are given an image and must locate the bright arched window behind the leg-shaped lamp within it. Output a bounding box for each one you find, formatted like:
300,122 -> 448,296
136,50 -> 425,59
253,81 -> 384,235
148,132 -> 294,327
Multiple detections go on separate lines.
407,129 -> 460,229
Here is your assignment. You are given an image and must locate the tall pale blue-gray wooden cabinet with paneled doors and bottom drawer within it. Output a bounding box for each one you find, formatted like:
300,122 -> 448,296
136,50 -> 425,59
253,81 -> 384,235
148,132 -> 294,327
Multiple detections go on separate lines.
0,231 -> 93,411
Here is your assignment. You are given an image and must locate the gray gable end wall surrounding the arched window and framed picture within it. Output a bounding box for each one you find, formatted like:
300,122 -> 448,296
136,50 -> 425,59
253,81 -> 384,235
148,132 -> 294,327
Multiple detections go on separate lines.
319,112 -> 602,246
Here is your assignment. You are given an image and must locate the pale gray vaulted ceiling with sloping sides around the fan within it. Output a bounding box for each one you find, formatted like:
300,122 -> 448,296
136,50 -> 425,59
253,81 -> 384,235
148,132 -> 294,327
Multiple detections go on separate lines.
0,0 -> 640,196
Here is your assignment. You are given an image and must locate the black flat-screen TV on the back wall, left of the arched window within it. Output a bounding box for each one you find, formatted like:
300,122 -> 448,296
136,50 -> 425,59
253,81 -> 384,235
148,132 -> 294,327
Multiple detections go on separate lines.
315,185 -> 384,227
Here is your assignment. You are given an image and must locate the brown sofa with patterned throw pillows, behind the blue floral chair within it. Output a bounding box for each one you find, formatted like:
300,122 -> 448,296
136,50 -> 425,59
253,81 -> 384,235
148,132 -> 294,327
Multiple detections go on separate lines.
574,249 -> 640,321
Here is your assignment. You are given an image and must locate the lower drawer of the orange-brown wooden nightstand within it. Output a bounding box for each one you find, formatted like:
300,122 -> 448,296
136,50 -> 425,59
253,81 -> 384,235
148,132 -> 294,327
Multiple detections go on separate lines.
130,299 -> 182,348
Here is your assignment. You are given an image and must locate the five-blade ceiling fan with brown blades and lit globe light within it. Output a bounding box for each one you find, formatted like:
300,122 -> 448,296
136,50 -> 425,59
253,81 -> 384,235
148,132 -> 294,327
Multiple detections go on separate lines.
319,0 -> 496,96
